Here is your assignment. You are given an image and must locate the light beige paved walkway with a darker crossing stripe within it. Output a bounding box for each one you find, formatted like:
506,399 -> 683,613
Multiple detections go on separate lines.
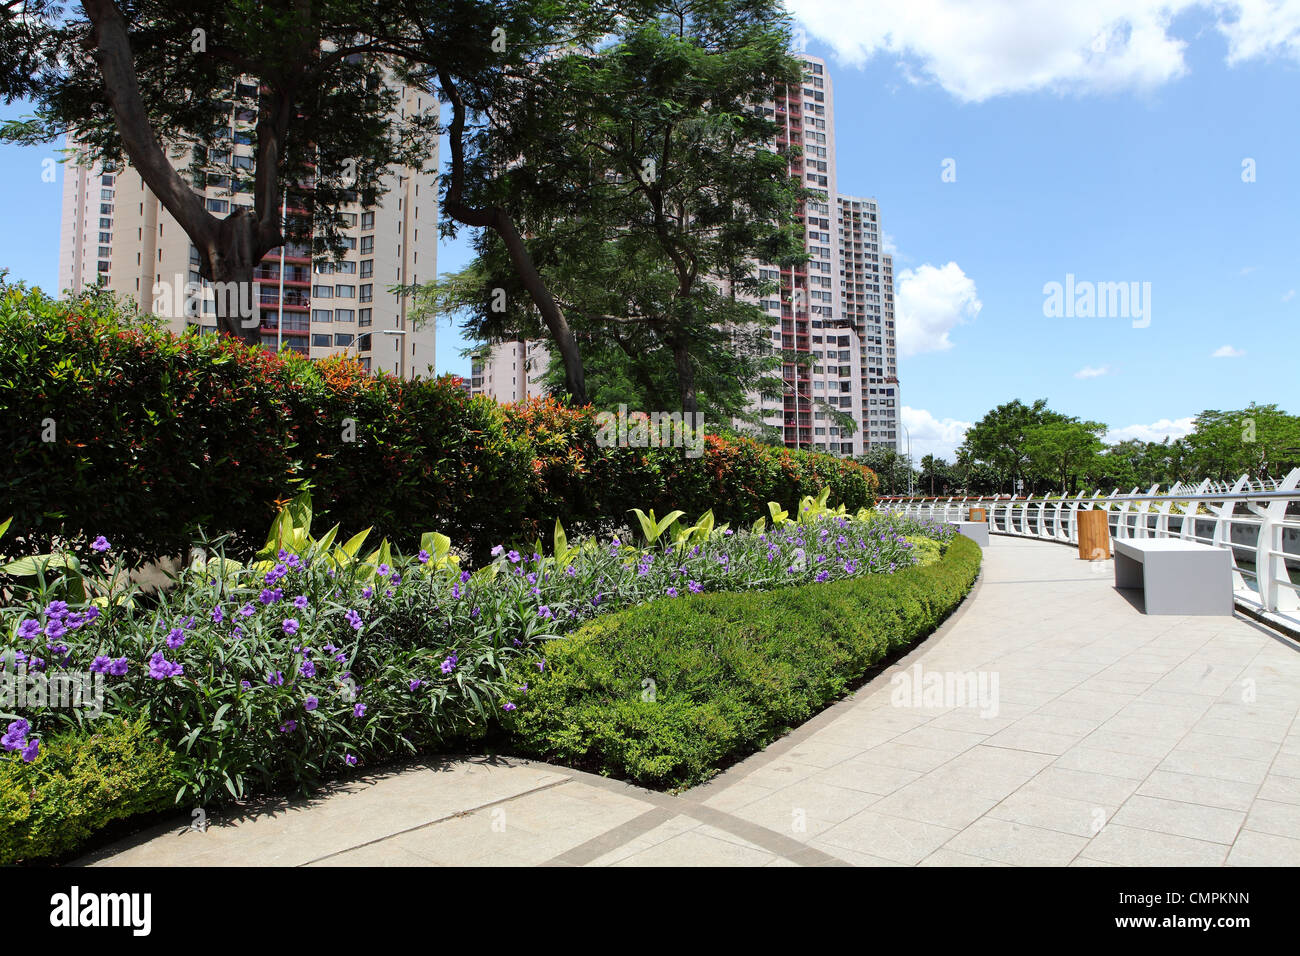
86,537 -> 1300,866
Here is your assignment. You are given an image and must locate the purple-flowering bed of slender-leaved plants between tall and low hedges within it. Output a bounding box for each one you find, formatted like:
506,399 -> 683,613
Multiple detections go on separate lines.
0,496 -> 945,801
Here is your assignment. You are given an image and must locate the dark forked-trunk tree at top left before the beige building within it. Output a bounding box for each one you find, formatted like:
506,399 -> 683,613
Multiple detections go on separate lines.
3,0 -> 447,341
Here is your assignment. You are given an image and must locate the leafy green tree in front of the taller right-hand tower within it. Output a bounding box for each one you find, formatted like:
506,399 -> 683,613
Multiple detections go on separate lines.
410,0 -> 803,418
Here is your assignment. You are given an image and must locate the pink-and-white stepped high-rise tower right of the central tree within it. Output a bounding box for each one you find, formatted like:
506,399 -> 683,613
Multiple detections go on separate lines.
471,53 -> 901,455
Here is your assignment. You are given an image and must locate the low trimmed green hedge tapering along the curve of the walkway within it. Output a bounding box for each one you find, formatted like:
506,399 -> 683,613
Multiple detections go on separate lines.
507,536 -> 982,788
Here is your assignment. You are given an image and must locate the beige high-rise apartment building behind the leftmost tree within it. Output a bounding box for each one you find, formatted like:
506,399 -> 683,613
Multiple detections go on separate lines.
59,83 -> 438,378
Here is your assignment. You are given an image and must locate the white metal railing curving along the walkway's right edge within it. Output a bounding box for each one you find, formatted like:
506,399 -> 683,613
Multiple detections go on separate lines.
879,468 -> 1300,628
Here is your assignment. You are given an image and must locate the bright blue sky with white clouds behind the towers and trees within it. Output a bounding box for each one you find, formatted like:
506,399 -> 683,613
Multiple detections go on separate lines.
0,0 -> 1300,455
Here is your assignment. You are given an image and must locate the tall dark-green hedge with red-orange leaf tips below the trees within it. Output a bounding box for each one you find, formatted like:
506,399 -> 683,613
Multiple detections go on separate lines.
0,285 -> 879,558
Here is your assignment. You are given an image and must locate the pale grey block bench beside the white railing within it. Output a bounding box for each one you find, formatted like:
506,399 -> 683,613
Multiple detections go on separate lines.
1114,537 -> 1232,614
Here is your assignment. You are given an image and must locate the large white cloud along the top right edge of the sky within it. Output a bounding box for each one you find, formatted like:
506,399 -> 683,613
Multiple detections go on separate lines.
787,0 -> 1300,101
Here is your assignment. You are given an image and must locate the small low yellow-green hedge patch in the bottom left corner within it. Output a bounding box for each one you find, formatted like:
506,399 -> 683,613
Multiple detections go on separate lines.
0,718 -> 179,865
